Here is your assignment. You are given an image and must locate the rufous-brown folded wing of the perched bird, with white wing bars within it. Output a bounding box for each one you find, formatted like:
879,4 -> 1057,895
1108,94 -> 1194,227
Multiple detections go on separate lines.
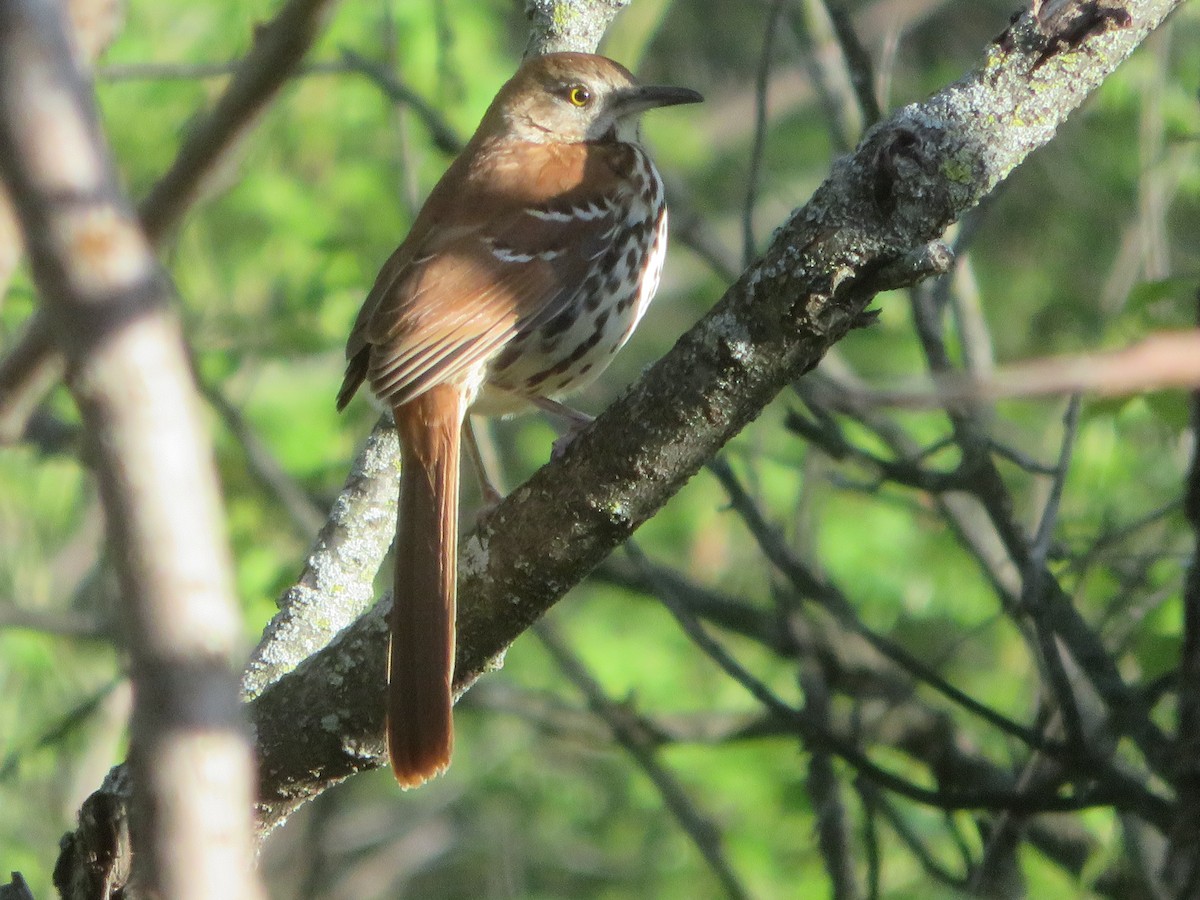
338,148 -> 623,406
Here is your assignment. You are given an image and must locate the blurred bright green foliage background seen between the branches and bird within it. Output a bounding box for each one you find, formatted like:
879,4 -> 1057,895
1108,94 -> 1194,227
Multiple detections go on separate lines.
0,0 -> 1200,900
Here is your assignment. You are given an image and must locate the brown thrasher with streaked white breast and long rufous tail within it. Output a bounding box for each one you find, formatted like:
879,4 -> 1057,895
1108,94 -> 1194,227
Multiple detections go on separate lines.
337,53 -> 701,787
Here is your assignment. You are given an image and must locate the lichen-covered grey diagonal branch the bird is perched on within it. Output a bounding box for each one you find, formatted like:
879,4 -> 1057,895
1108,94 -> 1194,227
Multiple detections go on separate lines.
252,0 -> 1178,823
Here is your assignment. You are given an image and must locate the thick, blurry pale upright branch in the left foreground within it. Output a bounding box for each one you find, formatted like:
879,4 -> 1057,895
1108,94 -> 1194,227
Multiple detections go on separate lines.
0,0 -> 260,898
